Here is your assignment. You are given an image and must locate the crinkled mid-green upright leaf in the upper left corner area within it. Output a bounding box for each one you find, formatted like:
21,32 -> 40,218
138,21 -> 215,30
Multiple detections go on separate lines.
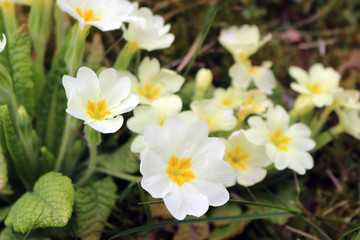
9,25 -> 35,116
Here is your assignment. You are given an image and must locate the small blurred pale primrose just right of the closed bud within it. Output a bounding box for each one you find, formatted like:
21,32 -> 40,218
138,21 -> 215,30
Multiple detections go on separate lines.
214,87 -> 245,108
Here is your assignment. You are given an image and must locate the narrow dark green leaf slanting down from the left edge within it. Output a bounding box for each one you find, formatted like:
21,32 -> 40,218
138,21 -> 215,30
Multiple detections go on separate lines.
0,105 -> 32,183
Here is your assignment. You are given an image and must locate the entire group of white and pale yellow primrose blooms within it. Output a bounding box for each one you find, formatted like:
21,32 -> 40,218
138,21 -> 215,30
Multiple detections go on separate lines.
57,0 -> 360,219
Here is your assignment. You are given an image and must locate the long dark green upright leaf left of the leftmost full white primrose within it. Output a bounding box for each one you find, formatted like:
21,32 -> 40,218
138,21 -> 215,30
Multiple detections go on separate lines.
36,33 -> 68,155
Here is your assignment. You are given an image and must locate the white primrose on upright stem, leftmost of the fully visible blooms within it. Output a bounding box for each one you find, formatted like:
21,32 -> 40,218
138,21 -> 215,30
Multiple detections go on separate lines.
62,67 -> 139,133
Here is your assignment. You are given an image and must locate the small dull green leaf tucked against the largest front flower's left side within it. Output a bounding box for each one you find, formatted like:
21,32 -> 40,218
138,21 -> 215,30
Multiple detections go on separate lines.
98,139 -> 139,173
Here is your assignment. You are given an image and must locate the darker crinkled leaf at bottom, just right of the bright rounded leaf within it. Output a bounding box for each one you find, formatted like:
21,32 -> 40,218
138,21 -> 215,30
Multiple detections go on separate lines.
75,177 -> 117,240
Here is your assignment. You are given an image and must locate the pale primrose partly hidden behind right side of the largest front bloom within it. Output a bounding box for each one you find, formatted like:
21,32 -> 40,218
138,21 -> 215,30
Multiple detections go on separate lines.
225,130 -> 272,186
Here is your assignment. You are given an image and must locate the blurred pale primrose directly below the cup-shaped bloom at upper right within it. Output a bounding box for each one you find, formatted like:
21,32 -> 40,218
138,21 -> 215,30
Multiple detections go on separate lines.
229,60 -> 276,94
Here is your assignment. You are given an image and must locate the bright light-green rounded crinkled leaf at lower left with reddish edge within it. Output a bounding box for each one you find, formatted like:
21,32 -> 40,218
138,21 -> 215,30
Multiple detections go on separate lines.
5,172 -> 74,233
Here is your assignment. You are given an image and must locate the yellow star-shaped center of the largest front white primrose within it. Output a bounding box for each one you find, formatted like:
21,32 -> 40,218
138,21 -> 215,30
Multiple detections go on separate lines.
166,155 -> 195,187
